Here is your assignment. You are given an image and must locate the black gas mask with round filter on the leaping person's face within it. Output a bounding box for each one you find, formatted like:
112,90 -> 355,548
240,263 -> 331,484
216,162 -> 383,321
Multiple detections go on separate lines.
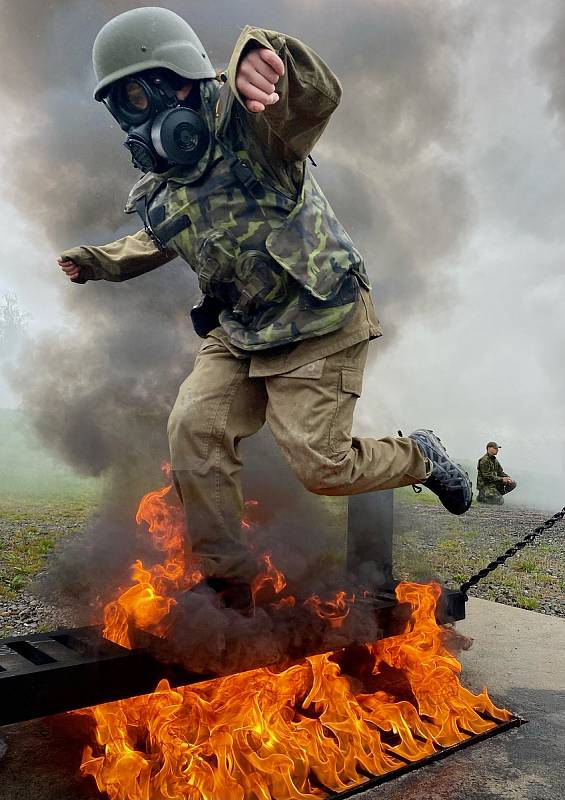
104,69 -> 210,173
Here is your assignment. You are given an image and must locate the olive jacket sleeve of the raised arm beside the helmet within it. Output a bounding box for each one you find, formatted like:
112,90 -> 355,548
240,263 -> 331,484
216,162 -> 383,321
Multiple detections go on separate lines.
227,26 -> 342,161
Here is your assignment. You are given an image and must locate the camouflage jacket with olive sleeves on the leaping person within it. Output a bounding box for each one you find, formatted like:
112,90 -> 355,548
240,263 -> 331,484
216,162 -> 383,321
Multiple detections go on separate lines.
61,28 -> 370,351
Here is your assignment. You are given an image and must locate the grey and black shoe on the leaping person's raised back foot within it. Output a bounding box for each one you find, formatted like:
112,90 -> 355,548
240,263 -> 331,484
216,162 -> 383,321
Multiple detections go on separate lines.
410,428 -> 473,514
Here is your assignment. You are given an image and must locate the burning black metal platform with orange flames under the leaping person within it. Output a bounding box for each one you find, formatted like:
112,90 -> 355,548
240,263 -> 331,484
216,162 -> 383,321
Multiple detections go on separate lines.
0,489 -> 532,800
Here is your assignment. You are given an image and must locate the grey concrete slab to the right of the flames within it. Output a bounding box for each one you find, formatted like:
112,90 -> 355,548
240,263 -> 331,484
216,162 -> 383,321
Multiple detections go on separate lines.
357,598 -> 565,800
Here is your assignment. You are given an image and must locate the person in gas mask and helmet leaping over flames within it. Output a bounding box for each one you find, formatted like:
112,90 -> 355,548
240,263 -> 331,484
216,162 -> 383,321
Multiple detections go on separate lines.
59,8 -> 472,607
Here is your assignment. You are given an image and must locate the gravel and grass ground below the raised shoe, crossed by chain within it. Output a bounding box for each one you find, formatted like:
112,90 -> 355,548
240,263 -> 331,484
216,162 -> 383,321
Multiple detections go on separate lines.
394,496 -> 565,617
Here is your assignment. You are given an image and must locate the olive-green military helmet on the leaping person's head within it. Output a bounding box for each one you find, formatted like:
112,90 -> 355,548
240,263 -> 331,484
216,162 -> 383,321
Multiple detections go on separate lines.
92,7 -> 216,100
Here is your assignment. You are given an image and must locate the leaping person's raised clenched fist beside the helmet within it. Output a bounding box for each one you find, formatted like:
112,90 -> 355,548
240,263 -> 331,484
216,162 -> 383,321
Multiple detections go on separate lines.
235,47 -> 284,113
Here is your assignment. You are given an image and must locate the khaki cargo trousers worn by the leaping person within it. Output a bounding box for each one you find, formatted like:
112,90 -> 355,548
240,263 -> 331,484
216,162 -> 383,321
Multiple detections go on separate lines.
168,337 -> 429,581
